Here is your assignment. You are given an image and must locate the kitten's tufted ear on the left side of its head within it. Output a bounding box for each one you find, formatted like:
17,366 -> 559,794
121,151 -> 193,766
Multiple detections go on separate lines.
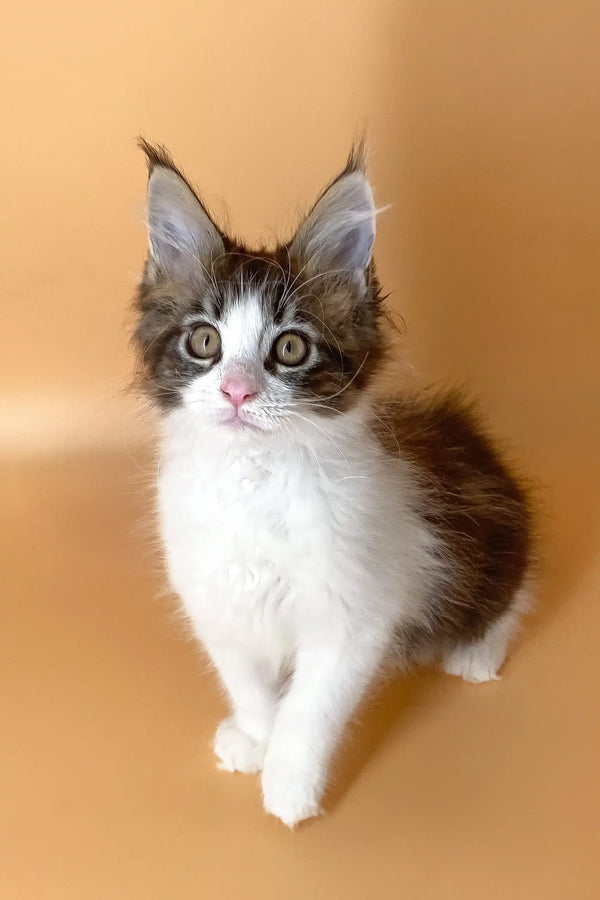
140,141 -> 225,277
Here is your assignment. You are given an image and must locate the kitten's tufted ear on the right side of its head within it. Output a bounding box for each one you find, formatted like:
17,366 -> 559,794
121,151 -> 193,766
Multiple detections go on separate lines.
290,147 -> 376,276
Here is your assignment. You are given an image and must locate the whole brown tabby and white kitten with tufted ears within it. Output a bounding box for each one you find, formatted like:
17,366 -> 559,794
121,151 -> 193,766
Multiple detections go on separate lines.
136,142 -> 531,826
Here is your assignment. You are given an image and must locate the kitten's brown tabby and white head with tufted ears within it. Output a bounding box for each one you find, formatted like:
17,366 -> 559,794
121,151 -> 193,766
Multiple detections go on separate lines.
135,141 -> 384,433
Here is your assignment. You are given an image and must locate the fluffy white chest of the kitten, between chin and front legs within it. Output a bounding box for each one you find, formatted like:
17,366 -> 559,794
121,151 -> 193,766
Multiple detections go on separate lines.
159,408 -> 434,654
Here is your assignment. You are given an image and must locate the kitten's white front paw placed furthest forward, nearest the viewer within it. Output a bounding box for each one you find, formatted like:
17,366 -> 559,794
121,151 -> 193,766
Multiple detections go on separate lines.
262,764 -> 323,828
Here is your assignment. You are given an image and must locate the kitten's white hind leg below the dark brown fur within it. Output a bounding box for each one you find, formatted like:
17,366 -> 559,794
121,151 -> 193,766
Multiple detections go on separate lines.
443,587 -> 529,684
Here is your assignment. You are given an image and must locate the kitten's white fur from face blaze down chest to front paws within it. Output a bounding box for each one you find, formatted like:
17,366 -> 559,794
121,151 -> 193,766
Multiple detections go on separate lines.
159,296 -> 524,826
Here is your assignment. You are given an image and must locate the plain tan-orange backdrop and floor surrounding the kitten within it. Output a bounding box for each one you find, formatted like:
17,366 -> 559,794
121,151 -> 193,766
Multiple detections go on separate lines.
0,0 -> 600,900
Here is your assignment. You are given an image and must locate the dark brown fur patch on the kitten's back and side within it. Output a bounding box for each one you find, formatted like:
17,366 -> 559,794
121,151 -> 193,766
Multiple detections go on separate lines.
373,393 -> 533,652
